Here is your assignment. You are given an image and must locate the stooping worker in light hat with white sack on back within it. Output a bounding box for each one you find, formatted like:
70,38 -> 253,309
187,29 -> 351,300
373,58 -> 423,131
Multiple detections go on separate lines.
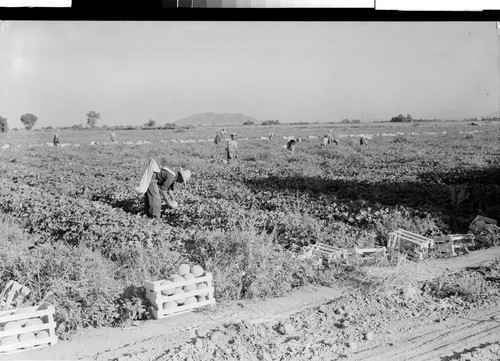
136,158 -> 191,218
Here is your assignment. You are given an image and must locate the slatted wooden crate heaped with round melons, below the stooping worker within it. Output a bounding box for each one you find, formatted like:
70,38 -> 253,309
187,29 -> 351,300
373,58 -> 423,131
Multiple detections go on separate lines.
143,272 -> 215,319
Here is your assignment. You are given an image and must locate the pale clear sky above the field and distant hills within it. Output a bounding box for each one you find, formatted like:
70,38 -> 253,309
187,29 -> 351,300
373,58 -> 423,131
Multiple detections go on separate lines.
0,21 -> 500,128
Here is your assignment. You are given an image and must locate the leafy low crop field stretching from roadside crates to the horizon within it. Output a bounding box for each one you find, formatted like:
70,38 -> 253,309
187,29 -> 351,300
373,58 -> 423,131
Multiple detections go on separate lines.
0,122 -> 500,334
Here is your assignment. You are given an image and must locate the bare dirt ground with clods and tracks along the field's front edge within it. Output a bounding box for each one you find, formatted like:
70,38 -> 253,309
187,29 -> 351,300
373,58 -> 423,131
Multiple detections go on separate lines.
0,247 -> 500,361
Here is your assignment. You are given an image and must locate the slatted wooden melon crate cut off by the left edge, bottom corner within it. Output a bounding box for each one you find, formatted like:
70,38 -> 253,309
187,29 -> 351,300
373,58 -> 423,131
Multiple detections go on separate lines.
0,302 -> 57,355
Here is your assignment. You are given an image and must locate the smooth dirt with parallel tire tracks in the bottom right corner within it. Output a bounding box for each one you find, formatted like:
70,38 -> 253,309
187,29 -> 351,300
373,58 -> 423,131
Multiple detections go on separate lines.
351,307 -> 500,361
